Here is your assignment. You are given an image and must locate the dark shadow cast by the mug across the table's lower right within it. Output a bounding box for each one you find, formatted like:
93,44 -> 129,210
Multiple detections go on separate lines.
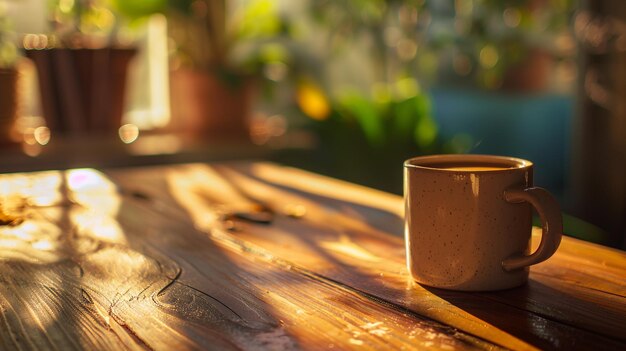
423,278 -> 626,350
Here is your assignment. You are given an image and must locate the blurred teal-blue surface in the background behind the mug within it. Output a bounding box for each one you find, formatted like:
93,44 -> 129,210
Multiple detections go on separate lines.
430,88 -> 574,201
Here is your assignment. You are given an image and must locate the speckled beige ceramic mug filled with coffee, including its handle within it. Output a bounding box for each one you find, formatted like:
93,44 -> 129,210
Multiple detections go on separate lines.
404,155 -> 563,291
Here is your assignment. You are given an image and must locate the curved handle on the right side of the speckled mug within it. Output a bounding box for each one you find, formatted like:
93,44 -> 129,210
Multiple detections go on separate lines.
502,187 -> 563,272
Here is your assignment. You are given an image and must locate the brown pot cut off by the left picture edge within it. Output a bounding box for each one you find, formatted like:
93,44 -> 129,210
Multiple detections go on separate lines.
0,68 -> 18,145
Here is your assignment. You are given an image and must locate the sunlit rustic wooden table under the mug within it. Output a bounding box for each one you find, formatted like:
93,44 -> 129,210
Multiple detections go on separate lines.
0,163 -> 626,350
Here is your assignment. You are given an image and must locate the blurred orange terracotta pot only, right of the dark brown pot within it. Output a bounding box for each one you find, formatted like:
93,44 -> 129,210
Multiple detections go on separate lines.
170,69 -> 253,140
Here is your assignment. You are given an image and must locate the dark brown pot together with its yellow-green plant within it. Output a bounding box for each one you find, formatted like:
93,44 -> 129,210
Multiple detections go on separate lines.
23,0 -> 136,136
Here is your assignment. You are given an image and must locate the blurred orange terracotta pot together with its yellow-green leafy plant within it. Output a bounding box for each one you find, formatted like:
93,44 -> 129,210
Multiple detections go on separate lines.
113,0 -> 281,140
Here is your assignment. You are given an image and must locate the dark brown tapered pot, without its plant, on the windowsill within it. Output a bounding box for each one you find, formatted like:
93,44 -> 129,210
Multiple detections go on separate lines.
26,48 -> 136,134
